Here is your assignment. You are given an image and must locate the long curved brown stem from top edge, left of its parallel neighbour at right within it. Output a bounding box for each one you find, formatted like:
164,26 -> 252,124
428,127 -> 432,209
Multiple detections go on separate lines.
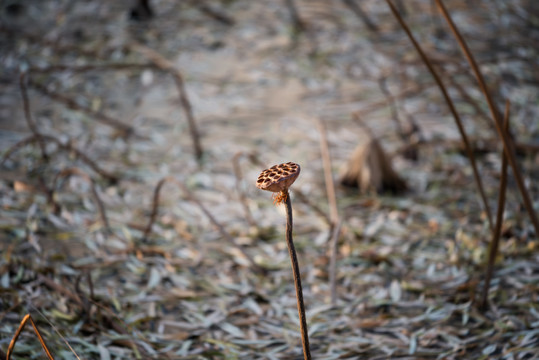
386,0 -> 494,231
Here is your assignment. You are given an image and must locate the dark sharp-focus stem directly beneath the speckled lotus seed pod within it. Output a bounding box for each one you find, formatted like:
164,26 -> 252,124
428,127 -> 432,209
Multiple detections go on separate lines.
285,194 -> 311,360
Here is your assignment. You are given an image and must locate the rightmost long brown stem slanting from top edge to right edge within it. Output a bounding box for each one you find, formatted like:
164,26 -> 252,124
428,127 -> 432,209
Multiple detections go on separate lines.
436,0 -> 539,236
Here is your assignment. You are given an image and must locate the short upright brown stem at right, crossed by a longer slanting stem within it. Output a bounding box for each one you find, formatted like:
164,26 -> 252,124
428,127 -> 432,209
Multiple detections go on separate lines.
481,101 -> 510,310
